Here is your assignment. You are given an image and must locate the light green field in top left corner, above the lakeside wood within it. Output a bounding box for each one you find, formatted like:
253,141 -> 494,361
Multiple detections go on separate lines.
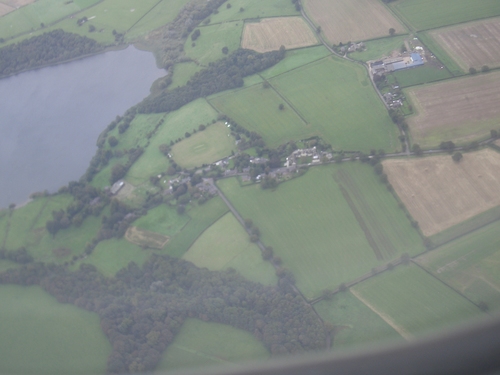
0,0 -> 98,39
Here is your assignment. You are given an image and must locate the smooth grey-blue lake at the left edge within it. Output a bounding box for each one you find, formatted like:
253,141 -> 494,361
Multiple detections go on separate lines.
0,47 -> 166,208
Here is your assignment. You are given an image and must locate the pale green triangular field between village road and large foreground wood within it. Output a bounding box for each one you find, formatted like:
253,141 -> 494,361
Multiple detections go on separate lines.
182,213 -> 278,285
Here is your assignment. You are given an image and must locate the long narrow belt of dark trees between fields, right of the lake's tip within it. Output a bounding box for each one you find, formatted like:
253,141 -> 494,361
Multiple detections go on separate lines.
138,48 -> 285,113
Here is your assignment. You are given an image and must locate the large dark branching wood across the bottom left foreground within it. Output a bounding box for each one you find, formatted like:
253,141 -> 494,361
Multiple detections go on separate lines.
0,255 -> 327,373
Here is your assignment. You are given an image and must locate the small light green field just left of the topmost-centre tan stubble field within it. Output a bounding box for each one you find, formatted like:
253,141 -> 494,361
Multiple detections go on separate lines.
184,21 -> 243,66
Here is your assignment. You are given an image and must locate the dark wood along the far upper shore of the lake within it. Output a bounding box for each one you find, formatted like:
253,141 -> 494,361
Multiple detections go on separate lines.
0,29 -> 103,76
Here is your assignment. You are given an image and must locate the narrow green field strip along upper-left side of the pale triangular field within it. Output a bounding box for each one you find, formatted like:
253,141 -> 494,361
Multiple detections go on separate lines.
163,197 -> 229,258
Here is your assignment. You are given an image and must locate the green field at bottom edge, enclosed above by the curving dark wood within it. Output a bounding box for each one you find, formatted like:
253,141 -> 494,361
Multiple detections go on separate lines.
155,319 -> 270,374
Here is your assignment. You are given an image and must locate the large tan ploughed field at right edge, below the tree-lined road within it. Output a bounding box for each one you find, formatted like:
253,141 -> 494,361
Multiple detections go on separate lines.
383,149 -> 500,236
